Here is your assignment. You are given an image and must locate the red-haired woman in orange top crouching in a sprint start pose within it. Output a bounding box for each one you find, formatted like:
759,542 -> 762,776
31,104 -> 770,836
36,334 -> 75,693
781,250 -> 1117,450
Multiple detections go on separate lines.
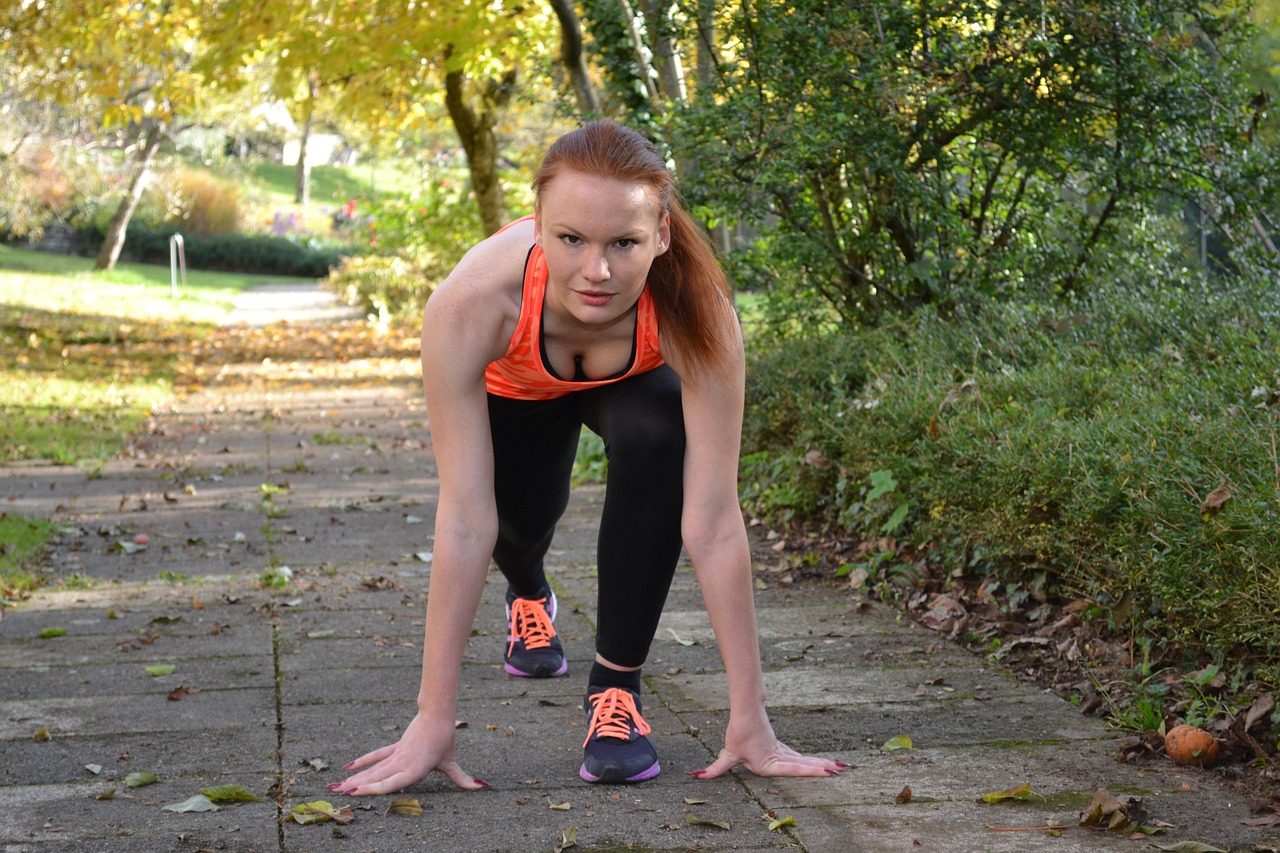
330,122 -> 847,795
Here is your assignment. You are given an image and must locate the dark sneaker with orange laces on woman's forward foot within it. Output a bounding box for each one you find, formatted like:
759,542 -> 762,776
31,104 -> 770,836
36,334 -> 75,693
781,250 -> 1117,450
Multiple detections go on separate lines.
577,688 -> 660,785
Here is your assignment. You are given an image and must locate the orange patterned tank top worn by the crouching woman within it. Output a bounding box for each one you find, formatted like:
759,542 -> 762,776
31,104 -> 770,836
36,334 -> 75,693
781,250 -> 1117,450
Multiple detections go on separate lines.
484,225 -> 663,400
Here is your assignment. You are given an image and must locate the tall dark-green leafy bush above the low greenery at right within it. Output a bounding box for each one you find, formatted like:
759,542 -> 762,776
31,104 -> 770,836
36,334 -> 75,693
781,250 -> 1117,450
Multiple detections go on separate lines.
678,0 -> 1275,321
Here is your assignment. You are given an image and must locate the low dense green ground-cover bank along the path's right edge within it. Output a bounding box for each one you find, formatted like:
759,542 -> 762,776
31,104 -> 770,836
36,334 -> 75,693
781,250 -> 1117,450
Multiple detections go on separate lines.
744,268 -> 1280,680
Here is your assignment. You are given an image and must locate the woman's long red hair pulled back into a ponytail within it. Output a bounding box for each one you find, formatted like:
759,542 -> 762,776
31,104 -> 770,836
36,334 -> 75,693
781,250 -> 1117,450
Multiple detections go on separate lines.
534,120 -> 732,376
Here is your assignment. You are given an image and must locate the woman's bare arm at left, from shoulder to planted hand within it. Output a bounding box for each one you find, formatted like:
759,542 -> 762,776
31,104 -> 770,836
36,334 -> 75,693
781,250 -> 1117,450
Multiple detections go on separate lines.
330,229 -> 527,795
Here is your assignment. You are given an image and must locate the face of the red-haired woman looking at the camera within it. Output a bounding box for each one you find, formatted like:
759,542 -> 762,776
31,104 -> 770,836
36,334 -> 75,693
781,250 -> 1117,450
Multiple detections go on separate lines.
534,170 -> 671,327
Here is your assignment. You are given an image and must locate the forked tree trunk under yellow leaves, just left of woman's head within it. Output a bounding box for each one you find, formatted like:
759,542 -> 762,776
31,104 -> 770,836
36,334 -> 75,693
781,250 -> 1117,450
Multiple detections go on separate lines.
444,69 -> 516,237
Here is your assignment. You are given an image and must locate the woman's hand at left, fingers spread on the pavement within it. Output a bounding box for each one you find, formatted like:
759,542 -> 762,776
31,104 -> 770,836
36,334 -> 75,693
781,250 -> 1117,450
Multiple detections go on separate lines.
329,713 -> 489,797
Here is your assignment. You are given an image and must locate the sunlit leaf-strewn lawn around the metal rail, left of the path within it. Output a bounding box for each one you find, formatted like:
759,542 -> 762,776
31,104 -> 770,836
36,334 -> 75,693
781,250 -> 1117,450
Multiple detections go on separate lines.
0,247 -> 285,464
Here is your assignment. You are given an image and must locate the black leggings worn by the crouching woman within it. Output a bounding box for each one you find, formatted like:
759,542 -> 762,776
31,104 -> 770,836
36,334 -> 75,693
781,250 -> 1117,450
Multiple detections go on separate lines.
489,365 -> 685,667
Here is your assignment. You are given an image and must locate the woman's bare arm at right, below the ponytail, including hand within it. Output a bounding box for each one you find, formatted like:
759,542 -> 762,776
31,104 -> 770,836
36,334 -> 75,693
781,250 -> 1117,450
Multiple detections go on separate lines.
673,311 -> 846,779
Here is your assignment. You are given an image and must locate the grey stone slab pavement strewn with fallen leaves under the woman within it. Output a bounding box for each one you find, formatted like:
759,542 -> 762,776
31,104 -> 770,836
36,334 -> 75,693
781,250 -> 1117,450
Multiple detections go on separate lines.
0,281 -> 1275,853
